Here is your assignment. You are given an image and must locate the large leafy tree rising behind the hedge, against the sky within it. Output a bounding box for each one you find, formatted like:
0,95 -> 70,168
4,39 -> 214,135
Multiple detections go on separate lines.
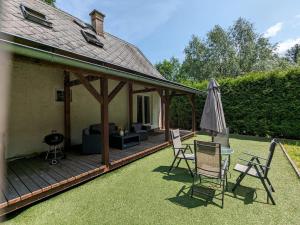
181,18 -> 279,80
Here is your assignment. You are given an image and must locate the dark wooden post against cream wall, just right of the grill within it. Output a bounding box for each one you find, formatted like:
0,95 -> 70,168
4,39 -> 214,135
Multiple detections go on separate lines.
64,71 -> 71,150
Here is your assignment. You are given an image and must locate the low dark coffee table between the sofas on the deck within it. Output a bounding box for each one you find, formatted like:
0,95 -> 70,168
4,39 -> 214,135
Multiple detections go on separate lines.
109,133 -> 140,150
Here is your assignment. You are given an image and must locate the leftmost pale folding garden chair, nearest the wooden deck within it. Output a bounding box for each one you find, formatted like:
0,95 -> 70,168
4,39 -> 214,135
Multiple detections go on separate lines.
168,129 -> 195,176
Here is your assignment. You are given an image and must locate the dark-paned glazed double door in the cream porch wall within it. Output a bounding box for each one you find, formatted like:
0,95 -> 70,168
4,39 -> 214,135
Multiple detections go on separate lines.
136,95 -> 151,124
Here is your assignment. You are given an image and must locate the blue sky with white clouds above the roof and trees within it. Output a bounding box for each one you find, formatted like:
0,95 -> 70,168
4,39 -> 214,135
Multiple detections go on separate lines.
57,0 -> 300,63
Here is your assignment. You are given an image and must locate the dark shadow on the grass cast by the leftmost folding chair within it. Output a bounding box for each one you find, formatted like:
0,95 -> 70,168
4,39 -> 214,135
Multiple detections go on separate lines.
153,166 -> 193,183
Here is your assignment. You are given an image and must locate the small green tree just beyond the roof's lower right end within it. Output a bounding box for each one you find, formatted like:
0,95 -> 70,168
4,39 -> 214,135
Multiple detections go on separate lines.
155,57 -> 181,81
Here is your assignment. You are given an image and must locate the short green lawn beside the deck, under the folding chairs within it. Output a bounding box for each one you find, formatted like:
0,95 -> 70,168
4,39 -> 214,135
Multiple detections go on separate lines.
4,136 -> 300,225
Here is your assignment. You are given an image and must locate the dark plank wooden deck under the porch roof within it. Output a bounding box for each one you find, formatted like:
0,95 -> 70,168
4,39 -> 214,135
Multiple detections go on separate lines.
0,131 -> 193,216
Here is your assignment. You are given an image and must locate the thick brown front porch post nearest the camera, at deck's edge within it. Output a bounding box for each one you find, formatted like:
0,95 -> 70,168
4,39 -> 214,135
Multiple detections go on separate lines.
100,77 -> 109,167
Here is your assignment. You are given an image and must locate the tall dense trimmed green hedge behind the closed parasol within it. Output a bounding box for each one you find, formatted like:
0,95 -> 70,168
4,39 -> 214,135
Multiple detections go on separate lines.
171,69 -> 300,139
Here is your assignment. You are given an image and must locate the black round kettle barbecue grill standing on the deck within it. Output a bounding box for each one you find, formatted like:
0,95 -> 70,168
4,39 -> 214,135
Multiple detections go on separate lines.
44,131 -> 64,165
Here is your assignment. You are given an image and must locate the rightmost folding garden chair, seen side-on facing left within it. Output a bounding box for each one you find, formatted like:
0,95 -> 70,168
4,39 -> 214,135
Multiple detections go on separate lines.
232,139 -> 278,205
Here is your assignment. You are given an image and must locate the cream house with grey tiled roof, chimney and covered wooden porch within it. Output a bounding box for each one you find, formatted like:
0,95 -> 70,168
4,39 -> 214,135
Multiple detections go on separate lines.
0,0 -> 202,213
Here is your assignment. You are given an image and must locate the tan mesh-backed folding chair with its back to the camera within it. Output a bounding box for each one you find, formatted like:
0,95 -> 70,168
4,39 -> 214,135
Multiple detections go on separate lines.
191,140 -> 228,208
